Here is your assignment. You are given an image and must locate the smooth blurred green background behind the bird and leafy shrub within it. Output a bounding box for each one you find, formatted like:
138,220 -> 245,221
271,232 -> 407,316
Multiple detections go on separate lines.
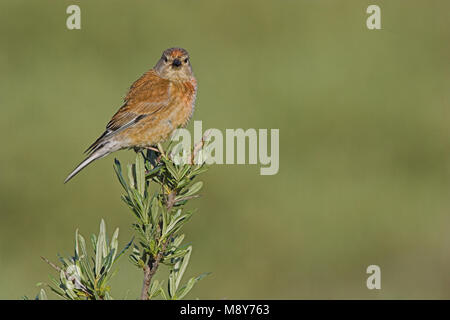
0,0 -> 450,299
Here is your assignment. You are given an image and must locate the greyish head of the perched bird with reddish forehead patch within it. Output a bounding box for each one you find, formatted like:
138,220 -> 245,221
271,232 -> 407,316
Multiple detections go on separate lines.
154,48 -> 193,81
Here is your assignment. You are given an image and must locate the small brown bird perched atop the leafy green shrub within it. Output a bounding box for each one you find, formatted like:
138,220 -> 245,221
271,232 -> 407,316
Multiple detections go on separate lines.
64,47 -> 197,183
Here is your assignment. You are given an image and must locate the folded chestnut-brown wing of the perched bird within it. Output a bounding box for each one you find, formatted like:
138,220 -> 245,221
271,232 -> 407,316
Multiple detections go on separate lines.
86,70 -> 170,152
